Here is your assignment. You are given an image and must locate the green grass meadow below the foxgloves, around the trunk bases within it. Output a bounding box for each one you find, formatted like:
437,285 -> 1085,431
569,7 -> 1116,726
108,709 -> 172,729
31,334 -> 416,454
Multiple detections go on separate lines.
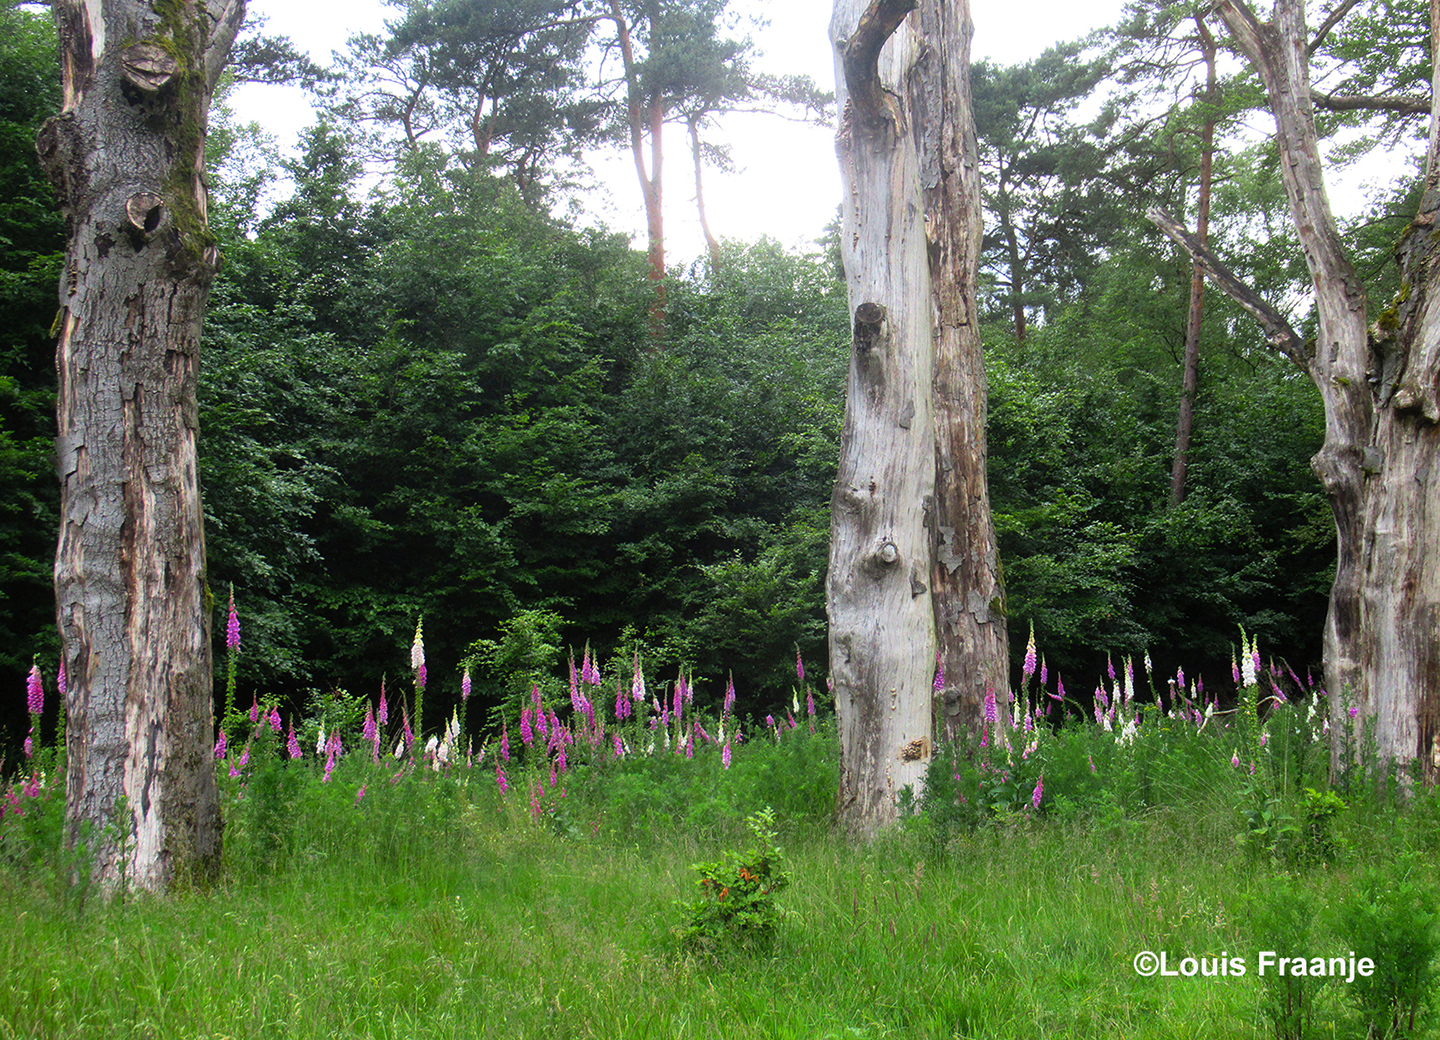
0,659 -> 1440,1040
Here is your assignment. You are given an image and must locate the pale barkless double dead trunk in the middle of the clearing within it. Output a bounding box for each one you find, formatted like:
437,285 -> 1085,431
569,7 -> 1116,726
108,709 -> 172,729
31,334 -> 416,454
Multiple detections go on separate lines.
827,0 -> 1004,834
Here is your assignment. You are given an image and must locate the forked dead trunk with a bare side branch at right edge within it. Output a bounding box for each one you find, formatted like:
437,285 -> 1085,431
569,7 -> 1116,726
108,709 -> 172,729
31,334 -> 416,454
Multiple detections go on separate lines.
1153,0 -> 1440,781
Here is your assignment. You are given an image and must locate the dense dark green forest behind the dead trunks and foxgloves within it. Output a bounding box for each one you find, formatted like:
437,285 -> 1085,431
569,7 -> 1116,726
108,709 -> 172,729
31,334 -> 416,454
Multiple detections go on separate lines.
0,0 -> 1428,745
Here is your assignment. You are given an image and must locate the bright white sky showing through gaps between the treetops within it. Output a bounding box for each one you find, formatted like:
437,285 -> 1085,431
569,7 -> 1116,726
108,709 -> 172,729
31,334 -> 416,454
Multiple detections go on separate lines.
230,0 -> 1123,264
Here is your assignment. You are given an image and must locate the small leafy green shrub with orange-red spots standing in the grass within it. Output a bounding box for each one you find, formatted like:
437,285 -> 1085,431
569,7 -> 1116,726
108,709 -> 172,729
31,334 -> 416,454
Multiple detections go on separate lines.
680,808 -> 791,956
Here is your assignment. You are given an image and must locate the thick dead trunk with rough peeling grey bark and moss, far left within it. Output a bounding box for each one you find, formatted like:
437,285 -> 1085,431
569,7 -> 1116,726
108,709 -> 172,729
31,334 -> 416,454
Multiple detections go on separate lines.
39,0 -> 245,890
